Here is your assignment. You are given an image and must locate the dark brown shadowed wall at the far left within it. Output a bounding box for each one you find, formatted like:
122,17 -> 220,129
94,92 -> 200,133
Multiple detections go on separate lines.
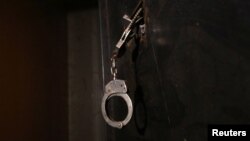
0,0 -> 68,141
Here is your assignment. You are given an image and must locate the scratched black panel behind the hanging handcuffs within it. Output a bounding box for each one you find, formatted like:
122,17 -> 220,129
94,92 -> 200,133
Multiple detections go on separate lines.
100,0 -> 250,141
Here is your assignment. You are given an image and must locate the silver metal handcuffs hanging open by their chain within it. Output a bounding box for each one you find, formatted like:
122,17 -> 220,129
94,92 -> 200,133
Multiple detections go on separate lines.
101,1 -> 145,129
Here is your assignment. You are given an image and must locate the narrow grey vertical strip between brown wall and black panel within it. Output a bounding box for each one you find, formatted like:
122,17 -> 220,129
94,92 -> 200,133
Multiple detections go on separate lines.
67,8 -> 105,141
